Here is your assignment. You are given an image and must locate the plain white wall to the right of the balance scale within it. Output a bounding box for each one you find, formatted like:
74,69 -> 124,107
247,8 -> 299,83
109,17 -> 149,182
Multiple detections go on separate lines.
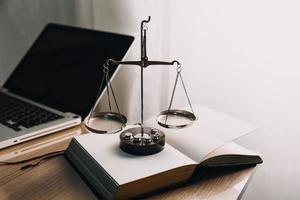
170,0 -> 300,199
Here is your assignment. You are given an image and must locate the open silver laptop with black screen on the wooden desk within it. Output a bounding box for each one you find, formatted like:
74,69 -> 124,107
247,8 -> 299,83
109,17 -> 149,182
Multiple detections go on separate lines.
0,23 -> 134,149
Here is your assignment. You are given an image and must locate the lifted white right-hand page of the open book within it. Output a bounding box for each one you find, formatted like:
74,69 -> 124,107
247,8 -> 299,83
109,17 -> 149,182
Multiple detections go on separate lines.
145,105 -> 258,163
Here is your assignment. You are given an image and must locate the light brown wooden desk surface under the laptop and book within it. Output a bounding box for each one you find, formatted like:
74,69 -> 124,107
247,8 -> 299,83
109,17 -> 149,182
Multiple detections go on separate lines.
0,126 -> 255,200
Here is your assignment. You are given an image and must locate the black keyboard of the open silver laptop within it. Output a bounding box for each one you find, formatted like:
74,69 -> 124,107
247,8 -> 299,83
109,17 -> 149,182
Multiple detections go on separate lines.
0,93 -> 63,131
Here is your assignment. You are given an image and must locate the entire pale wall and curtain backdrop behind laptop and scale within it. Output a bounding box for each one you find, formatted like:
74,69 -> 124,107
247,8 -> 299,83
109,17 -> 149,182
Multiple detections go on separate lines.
0,0 -> 300,199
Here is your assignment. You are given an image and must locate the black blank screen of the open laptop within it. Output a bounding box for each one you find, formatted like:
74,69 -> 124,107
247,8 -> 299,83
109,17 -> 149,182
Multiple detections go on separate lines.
4,24 -> 134,118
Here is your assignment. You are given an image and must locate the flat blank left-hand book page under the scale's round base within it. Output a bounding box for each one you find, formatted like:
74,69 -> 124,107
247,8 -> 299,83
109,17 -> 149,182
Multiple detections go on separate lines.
75,133 -> 197,185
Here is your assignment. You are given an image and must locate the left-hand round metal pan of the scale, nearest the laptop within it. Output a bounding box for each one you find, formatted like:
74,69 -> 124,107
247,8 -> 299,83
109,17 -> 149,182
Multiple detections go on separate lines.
84,112 -> 127,134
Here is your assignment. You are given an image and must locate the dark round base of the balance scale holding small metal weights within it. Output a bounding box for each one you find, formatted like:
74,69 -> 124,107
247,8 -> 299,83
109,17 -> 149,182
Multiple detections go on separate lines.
120,127 -> 165,156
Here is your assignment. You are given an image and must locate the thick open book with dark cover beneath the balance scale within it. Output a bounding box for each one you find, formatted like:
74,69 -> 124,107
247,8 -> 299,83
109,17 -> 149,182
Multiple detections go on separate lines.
66,106 -> 262,199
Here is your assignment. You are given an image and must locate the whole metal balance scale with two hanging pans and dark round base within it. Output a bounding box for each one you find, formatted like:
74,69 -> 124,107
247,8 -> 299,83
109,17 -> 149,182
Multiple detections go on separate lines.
84,16 -> 197,155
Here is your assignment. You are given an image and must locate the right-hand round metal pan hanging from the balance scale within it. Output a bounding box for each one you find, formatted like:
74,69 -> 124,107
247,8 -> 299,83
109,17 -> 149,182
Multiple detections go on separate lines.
156,109 -> 197,129
